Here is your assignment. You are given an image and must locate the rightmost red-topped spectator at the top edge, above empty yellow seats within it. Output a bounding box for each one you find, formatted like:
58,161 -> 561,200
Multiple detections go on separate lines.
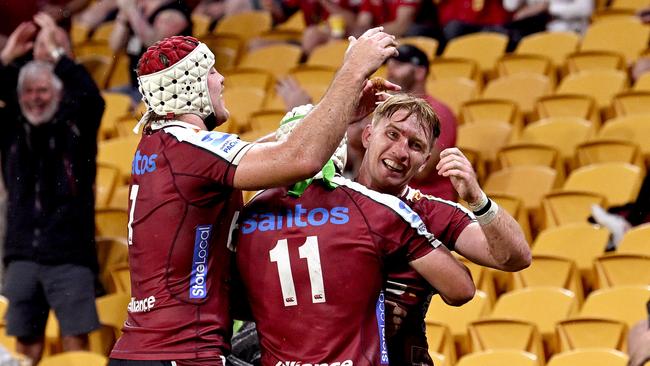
437,0 -> 511,45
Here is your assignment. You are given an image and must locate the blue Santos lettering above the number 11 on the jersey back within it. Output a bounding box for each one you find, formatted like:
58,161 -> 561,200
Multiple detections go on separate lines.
241,205 -> 350,234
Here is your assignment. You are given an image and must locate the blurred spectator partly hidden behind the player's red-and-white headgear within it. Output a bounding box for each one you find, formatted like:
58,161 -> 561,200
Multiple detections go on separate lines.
110,0 -> 192,105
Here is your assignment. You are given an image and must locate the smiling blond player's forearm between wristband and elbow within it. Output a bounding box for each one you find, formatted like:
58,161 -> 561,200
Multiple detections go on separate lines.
481,212 -> 532,272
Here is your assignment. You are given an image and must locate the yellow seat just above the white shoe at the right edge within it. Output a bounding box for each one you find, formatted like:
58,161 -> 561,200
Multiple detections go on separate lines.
562,162 -> 643,206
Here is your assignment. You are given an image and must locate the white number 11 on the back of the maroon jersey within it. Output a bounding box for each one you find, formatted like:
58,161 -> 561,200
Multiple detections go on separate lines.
269,236 -> 325,306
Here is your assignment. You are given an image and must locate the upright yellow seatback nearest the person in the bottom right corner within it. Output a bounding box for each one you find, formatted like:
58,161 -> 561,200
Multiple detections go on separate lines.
555,318 -> 627,352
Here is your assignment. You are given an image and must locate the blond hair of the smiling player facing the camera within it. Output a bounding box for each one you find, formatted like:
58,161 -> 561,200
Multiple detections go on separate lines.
372,93 -> 440,149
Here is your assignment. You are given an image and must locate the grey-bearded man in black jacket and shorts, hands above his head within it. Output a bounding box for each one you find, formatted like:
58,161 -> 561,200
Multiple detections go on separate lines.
0,13 -> 104,364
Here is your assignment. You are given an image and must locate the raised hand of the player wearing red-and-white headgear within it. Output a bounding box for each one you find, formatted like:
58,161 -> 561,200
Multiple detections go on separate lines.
342,27 -> 398,78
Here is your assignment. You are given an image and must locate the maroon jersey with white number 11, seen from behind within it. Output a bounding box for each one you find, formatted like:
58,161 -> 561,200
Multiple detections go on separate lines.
237,177 -> 440,366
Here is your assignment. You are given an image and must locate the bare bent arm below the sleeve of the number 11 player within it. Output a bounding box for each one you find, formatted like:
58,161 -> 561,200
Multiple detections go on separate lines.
409,245 -> 476,306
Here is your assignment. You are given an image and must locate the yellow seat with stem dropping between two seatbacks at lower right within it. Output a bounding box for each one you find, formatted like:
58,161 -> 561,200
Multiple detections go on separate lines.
490,286 -> 578,350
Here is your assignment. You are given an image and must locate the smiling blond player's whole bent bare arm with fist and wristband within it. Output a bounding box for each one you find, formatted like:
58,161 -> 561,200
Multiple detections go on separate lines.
436,148 -> 531,272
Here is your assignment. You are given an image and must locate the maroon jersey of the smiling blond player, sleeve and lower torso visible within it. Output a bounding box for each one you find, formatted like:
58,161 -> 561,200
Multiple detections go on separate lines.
386,187 -> 475,366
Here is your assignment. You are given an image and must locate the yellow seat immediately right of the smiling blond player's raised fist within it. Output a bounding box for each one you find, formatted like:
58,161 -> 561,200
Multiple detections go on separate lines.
484,165 -> 557,210
